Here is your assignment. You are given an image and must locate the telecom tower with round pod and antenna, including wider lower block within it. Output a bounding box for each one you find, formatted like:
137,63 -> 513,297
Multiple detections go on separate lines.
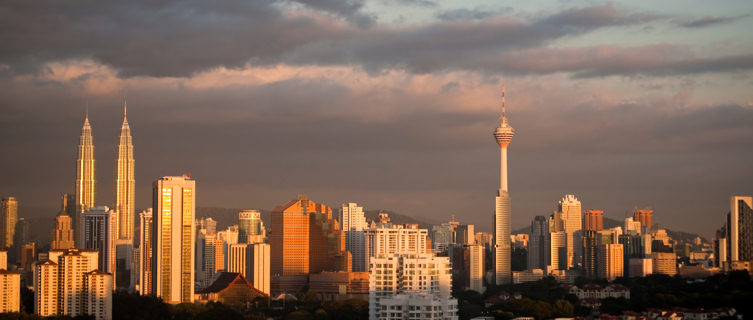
494,85 -> 515,285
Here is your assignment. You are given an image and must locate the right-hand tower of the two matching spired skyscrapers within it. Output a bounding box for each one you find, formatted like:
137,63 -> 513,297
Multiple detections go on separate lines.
115,104 -> 136,242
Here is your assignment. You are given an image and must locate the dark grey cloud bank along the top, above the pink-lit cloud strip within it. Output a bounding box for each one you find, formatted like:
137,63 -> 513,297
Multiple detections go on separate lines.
0,0 -> 680,77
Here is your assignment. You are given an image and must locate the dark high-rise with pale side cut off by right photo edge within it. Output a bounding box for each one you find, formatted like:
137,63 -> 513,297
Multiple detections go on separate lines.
724,196 -> 753,269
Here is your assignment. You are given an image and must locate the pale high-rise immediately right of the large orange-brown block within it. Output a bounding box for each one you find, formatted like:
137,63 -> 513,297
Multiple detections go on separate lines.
340,202 -> 369,272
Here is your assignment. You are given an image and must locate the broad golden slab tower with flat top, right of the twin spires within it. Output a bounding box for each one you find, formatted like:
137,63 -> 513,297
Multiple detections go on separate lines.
152,175 -> 196,303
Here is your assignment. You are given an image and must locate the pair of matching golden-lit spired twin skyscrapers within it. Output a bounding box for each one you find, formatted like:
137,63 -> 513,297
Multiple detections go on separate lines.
72,106 -> 136,241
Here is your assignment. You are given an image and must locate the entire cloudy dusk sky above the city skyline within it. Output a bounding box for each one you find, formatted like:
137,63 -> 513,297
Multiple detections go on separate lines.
0,0 -> 753,236
